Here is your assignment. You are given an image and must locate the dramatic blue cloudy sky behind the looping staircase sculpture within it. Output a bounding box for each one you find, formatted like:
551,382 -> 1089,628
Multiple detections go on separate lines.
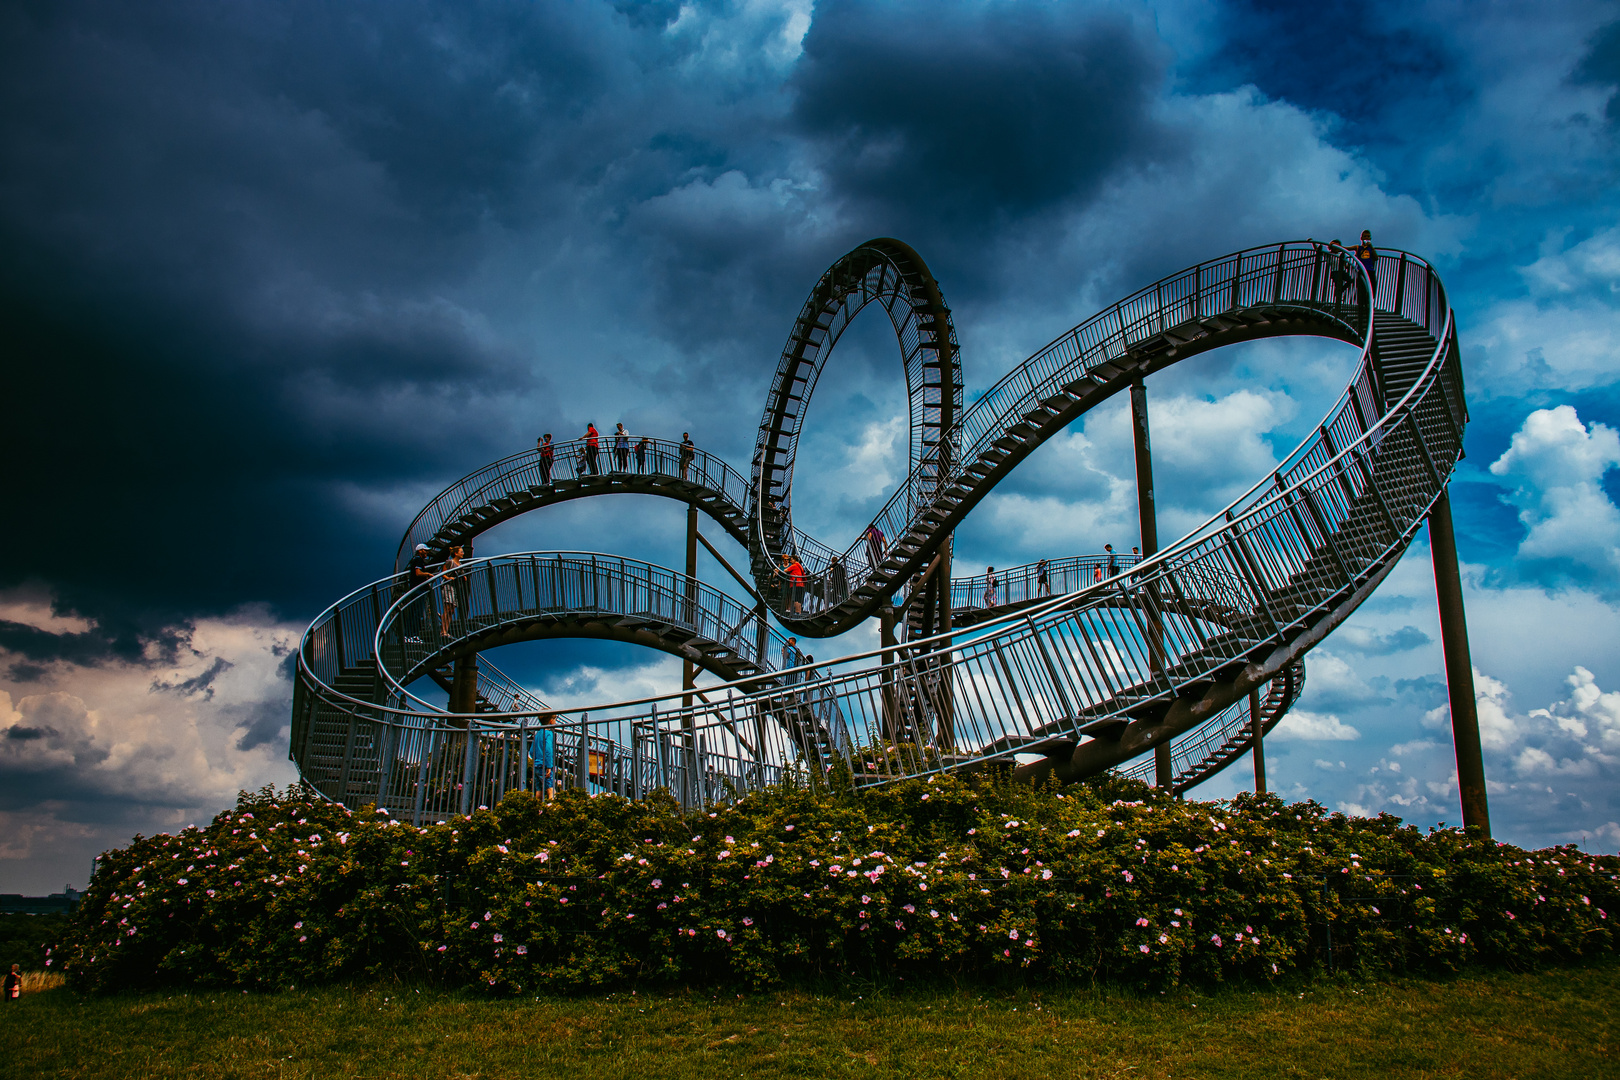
0,0 -> 1620,892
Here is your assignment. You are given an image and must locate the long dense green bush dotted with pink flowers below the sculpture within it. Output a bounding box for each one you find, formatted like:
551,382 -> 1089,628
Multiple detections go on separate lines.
55,777 -> 1620,993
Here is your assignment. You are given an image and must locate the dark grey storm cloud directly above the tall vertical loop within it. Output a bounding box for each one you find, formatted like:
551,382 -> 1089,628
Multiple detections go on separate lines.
794,2 -> 1163,246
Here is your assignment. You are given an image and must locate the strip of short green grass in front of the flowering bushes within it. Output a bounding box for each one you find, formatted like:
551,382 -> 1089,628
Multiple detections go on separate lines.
0,960 -> 1620,1080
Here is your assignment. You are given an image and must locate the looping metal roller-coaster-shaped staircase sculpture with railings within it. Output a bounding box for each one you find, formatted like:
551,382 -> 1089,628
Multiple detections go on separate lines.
290,240 -> 1468,821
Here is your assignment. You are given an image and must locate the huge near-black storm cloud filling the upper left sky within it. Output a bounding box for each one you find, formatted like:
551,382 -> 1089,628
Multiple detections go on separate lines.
0,3 -> 644,628
